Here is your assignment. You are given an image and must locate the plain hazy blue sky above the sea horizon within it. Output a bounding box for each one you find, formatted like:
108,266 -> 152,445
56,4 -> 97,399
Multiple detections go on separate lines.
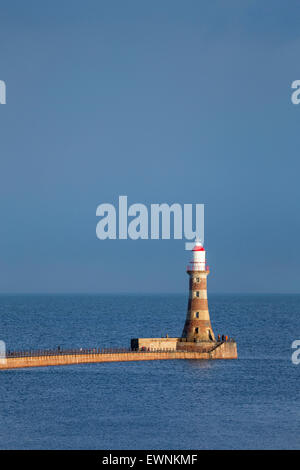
0,0 -> 300,293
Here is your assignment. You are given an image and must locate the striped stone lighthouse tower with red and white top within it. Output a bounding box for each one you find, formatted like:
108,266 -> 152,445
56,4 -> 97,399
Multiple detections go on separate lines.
182,241 -> 216,342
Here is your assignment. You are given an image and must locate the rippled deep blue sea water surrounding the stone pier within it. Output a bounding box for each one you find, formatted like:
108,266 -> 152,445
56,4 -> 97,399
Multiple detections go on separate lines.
0,295 -> 300,450
